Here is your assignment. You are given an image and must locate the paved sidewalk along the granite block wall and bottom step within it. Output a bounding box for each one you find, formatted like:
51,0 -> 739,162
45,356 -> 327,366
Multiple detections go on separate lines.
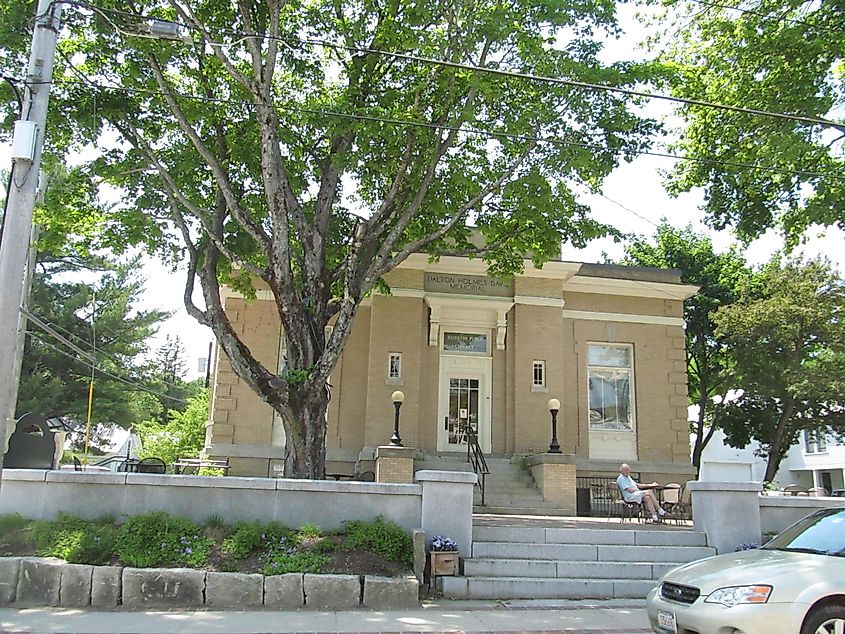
0,600 -> 651,634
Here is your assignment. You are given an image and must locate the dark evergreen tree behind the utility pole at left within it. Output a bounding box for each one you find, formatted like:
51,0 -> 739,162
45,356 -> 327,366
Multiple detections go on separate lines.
17,252 -> 168,426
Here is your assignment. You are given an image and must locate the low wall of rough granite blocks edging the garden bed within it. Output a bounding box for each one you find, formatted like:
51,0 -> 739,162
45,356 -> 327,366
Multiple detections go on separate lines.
0,557 -> 419,610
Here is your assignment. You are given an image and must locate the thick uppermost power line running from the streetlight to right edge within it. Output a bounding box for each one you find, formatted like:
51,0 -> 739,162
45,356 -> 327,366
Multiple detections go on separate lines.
62,0 -> 843,129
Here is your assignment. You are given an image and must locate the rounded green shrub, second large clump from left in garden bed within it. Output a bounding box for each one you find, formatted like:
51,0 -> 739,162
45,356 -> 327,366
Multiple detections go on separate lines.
115,513 -> 213,568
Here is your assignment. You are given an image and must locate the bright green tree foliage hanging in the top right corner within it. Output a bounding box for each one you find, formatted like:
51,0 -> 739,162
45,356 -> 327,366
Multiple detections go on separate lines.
662,0 -> 845,245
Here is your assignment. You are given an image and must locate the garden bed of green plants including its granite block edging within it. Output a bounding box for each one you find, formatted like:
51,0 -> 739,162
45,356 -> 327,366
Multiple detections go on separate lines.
0,513 -> 417,609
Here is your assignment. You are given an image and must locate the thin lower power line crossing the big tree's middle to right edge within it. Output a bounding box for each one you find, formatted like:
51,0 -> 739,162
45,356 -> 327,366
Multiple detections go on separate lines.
49,71 -> 845,180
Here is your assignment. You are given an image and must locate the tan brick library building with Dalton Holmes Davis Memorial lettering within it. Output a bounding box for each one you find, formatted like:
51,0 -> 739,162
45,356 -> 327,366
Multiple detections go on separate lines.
207,255 -> 696,481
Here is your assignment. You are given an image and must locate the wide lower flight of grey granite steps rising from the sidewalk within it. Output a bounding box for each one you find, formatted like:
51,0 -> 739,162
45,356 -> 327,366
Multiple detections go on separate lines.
438,515 -> 716,600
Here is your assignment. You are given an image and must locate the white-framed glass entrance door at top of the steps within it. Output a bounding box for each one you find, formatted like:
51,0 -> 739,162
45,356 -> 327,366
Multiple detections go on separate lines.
437,358 -> 490,453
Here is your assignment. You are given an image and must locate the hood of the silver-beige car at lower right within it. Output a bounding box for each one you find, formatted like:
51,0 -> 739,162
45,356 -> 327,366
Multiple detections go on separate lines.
663,550 -> 820,595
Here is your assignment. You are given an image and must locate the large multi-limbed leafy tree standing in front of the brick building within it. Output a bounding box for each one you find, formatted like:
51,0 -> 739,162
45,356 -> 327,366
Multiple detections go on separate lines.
3,0 -> 654,478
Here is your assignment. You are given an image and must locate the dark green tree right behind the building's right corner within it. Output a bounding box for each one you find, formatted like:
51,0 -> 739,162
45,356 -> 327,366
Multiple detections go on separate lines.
622,221 -> 751,471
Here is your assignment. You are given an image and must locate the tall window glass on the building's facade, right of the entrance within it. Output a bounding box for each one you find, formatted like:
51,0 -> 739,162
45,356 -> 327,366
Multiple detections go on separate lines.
587,344 -> 634,431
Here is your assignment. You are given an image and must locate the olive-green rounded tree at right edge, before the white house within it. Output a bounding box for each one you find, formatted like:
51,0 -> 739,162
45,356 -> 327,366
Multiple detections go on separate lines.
714,258 -> 845,482
